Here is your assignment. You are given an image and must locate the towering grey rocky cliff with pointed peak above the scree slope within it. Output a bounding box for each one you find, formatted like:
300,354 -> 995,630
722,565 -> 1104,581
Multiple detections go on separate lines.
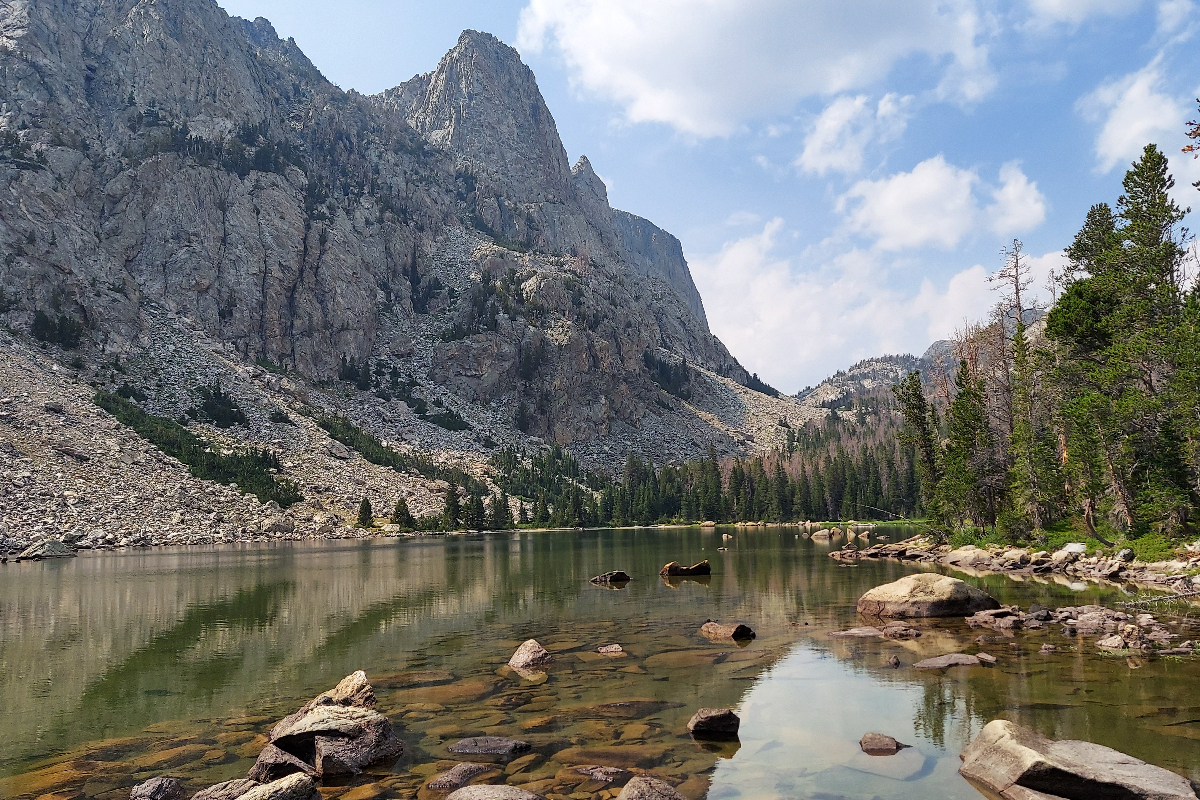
0,0 -> 822,474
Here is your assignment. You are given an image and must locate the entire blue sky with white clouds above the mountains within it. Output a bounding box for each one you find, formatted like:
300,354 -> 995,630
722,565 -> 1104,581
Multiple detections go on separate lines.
221,0 -> 1200,392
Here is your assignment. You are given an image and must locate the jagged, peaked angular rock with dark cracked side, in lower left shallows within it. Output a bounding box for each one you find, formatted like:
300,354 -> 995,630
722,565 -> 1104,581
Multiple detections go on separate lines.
250,672 -> 404,782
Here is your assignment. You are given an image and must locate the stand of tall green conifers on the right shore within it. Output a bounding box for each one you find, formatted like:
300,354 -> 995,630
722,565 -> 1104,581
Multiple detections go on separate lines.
895,145 -> 1200,559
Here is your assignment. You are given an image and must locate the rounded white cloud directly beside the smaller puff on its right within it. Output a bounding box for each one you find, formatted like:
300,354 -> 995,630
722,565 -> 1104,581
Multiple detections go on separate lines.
839,155 -> 979,251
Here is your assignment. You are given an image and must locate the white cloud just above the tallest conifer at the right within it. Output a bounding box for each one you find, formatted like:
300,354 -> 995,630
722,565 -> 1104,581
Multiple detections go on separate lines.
1075,54 -> 1187,173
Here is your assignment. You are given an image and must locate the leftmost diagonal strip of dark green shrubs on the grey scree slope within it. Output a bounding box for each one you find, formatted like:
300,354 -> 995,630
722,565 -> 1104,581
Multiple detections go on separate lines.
95,391 -> 304,507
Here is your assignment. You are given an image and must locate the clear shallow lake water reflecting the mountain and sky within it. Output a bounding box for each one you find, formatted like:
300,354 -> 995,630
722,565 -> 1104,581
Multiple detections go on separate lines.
0,528 -> 1200,800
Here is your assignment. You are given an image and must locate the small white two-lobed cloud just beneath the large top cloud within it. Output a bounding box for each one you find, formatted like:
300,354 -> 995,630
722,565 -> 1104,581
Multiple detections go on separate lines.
796,94 -> 912,175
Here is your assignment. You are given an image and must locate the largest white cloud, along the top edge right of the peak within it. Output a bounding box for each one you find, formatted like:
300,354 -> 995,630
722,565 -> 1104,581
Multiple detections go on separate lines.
517,0 -> 995,137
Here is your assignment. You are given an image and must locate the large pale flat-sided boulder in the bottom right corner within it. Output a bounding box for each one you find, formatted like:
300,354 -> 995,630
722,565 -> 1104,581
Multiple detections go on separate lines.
959,720 -> 1196,800
